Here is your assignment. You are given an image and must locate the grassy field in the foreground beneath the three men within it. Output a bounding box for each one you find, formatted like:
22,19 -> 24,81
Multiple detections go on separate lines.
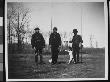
8,53 -> 105,79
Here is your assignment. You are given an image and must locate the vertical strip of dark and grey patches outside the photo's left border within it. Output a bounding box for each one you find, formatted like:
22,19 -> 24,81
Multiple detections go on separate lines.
0,0 -> 3,81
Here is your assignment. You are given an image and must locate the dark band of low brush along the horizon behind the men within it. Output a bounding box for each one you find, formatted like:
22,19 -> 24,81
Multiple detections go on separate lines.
8,43 -> 105,55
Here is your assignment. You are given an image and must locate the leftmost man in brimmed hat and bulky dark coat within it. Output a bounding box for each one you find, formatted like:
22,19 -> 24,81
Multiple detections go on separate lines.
31,27 -> 45,64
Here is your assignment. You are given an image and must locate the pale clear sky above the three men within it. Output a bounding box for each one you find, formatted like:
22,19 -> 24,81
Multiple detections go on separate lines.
7,2 -> 105,47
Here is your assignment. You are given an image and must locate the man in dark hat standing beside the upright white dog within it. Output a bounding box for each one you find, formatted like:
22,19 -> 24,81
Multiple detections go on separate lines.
72,29 -> 83,63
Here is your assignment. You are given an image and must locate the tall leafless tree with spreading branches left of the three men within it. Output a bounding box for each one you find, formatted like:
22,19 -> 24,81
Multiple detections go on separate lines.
7,3 -> 30,52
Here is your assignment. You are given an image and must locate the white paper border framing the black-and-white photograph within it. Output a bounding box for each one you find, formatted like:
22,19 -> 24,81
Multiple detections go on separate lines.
5,0 -> 108,81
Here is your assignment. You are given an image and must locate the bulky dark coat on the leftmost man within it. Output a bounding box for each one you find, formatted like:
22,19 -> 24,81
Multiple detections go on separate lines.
31,33 -> 45,49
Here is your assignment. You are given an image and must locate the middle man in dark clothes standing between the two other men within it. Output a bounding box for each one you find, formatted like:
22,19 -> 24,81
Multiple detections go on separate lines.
49,27 -> 61,64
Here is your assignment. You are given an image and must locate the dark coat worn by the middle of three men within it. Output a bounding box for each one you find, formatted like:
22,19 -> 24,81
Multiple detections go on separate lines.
49,33 -> 61,47
